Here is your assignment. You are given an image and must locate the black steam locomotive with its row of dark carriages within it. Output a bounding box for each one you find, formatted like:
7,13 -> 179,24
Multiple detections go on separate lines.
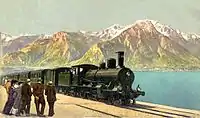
1,51 -> 145,105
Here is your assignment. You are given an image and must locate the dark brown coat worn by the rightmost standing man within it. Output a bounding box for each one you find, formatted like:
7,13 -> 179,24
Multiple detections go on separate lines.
45,85 -> 56,102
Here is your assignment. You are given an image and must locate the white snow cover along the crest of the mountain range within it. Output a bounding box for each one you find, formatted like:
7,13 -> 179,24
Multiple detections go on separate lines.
0,19 -> 200,41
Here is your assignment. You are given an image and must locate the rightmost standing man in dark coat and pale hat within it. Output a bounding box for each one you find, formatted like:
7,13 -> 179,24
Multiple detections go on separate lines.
45,81 -> 56,117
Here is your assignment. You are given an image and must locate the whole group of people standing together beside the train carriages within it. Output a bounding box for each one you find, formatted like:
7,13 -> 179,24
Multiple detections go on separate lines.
3,79 -> 56,117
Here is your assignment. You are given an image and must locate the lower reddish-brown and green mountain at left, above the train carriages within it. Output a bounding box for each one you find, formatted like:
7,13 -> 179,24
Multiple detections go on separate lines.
0,32 -> 98,66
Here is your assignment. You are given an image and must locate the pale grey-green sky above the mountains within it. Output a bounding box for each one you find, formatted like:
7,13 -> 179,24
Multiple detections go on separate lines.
0,0 -> 200,35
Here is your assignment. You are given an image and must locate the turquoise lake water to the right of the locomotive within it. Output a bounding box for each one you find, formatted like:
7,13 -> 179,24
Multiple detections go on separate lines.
133,72 -> 200,110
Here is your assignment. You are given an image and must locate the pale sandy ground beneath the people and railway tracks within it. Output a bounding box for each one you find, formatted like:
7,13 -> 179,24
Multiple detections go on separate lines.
0,86 -> 200,118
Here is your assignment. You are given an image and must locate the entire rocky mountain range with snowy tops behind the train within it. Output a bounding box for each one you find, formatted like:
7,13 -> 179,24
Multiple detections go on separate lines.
0,19 -> 200,72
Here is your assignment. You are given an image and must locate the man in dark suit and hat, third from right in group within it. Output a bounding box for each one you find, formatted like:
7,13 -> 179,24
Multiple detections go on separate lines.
20,79 -> 32,116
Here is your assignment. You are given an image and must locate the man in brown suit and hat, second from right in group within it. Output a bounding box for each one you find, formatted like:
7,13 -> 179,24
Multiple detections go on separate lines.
33,78 -> 45,116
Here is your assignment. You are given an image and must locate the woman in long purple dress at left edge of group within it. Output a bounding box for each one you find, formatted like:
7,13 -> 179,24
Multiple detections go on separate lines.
3,80 -> 17,115
